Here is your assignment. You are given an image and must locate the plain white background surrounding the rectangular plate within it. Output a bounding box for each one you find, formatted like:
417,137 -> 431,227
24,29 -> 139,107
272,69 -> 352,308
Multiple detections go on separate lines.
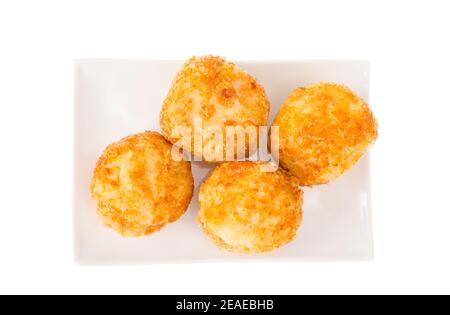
0,0 -> 450,294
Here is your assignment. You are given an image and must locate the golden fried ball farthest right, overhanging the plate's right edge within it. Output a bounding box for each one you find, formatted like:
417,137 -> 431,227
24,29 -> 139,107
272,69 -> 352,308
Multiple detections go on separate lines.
272,83 -> 377,186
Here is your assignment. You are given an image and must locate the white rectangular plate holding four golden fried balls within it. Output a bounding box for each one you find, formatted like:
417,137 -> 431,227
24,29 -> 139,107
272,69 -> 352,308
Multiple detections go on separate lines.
74,60 -> 373,264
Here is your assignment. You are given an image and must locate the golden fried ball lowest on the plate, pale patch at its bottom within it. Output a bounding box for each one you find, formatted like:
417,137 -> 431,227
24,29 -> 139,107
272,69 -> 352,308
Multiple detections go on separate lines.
198,162 -> 303,253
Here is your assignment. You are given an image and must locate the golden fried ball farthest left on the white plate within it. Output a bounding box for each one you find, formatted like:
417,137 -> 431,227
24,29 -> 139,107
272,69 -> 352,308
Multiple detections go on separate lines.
91,132 -> 194,237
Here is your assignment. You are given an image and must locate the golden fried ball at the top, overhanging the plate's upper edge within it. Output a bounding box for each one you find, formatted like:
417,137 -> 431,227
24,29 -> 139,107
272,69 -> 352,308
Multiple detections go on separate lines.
160,56 -> 270,162
